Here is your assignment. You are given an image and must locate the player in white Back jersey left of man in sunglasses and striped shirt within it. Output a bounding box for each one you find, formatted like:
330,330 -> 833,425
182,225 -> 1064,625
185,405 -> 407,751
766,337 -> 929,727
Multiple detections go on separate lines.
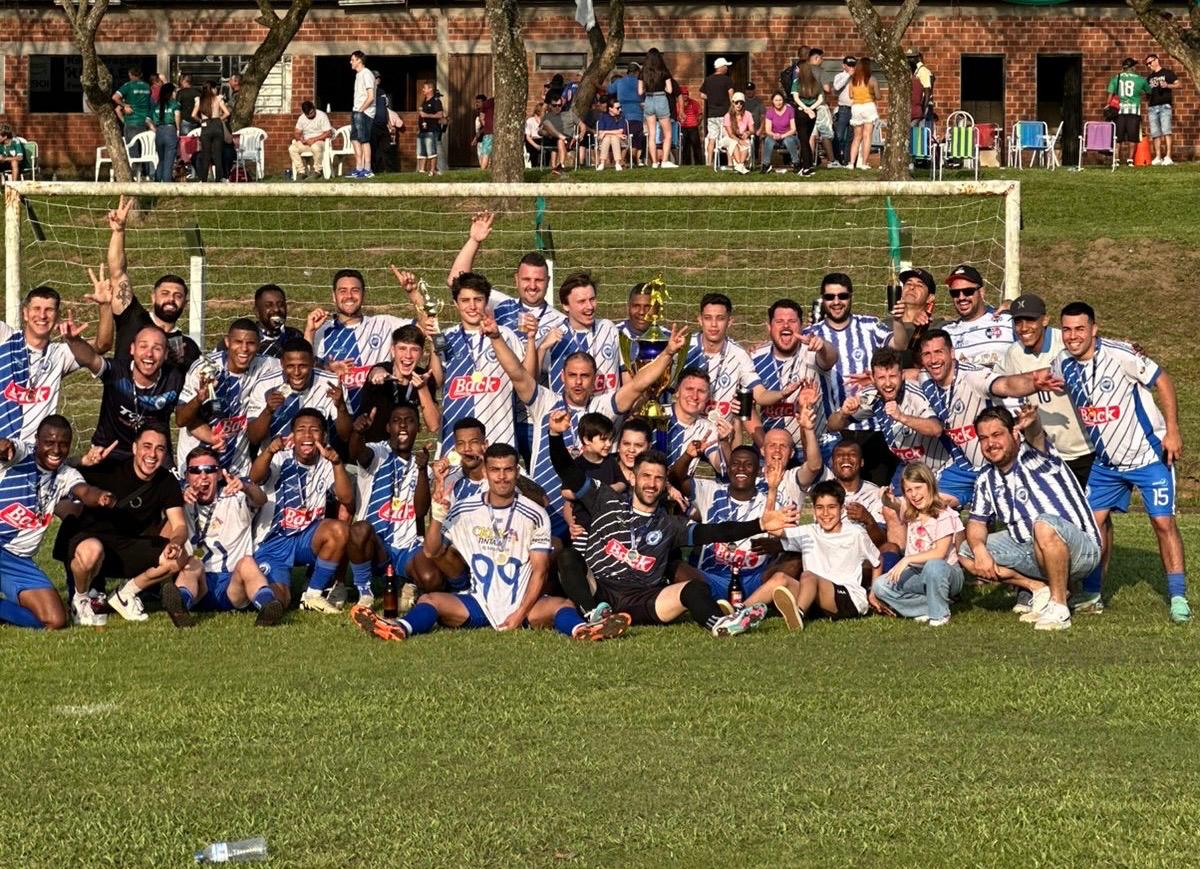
750,299 -> 838,461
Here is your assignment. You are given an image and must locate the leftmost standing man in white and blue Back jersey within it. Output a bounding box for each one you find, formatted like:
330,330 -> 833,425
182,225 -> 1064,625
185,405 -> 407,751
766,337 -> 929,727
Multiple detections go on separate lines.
0,287 -> 79,444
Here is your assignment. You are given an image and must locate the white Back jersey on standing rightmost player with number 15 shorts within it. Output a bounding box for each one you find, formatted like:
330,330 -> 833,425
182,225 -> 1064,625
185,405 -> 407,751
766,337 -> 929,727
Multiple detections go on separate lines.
1051,338 -> 1166,471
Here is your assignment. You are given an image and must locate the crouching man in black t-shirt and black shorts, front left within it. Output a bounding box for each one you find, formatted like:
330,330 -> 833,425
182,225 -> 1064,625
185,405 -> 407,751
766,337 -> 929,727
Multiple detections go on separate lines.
54,421 -> 190,622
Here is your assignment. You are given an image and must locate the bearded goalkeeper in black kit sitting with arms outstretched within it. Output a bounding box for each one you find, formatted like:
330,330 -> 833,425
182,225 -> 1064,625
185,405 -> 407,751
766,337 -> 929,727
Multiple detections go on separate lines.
550,410 -> 799,636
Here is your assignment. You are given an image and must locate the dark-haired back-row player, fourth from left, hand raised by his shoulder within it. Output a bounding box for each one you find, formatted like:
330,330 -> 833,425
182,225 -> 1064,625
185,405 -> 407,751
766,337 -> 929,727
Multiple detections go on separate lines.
304,269 -> 416,416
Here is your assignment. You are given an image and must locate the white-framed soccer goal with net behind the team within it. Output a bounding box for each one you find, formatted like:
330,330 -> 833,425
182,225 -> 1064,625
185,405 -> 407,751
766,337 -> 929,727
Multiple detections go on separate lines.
5,180 -> 1020,437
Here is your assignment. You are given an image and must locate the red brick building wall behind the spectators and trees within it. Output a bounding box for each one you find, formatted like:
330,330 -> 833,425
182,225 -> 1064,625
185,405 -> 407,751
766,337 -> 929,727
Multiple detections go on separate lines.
0,0 -> 1200,178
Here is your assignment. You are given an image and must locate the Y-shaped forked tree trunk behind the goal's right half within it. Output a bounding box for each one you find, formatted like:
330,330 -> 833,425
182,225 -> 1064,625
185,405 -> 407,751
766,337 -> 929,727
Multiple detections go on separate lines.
846,0 -> 920,181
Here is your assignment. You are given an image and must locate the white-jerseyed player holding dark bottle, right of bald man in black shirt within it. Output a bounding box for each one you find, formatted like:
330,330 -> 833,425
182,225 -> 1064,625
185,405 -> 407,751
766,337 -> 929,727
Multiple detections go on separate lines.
175,317 -> 283,475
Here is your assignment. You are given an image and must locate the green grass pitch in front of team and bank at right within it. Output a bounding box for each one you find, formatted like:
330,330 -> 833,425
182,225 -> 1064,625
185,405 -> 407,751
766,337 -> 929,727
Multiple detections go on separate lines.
0,167 -> 1200,867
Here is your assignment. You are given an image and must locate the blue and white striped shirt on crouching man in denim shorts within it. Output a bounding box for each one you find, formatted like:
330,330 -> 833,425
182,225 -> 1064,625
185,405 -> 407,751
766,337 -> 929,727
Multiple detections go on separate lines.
971,442 -> 1100,545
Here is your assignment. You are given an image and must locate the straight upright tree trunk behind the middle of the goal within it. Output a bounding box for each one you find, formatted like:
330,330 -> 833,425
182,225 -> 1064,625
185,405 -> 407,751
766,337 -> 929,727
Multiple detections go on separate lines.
485,0 -> 529,182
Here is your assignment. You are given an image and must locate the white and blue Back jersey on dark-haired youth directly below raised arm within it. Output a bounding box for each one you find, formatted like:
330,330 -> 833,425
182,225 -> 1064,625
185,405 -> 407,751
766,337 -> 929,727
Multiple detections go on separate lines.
442,324 -> 524,453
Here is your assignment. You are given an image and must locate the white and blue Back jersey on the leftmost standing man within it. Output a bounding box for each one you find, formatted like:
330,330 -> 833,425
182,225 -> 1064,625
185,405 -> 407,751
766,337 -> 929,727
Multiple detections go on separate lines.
0,323 -> 79,443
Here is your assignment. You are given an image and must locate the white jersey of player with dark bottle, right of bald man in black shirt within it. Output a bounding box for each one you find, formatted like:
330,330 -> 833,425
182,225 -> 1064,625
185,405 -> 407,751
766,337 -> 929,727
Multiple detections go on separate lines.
178,350 -> 283,475
